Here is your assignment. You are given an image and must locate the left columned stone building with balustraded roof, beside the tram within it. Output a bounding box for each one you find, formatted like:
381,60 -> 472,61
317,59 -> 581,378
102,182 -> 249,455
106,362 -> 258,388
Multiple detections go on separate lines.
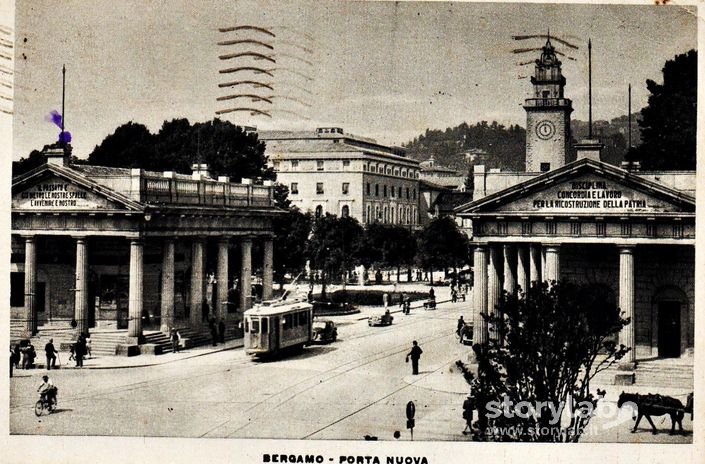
10,148 -> 281,352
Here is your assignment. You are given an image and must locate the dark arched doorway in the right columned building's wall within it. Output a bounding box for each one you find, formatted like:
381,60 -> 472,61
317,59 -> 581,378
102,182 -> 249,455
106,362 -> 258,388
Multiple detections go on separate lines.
651,286 -> 688,358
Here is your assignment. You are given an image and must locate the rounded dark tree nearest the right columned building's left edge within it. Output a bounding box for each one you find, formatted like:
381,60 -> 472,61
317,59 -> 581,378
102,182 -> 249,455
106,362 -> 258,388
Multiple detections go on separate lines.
416,216 -> 470,284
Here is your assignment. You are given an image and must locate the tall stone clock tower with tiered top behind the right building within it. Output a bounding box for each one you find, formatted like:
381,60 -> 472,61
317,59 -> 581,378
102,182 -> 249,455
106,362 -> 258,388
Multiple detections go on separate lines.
524,37 -> 573,172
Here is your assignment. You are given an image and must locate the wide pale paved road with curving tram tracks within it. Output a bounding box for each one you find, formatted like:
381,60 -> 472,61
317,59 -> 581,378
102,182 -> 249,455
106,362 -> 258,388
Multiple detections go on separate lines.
10,303 -> 470,440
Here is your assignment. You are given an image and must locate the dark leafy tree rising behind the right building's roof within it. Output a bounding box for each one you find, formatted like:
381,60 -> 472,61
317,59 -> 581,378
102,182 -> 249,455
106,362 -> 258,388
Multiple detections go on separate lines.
630,50 -> 698,170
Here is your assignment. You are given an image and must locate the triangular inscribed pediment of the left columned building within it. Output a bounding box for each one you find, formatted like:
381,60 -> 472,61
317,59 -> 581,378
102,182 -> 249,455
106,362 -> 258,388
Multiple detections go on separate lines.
12,165 -> 143,212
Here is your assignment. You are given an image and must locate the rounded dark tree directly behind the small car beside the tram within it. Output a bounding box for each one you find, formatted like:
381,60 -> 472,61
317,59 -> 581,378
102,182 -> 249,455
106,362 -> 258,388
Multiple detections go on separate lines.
307,213 -> 364,298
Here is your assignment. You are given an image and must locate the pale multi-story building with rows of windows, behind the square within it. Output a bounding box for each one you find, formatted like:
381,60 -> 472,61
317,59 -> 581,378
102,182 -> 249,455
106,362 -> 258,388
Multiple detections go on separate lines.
259,127 -> 420,226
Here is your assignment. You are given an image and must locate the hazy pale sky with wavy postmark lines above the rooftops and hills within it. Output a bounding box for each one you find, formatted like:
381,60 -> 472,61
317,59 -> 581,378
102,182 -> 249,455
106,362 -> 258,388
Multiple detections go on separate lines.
13,0 -> 697,159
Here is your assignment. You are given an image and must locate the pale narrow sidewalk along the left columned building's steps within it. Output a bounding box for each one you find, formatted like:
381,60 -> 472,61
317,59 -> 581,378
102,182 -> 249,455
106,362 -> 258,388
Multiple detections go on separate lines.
15,338 -> 244,375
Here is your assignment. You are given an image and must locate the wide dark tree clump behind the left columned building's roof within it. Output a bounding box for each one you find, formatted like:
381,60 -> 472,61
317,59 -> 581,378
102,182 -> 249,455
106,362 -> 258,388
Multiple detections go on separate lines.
88,119 -> 275,182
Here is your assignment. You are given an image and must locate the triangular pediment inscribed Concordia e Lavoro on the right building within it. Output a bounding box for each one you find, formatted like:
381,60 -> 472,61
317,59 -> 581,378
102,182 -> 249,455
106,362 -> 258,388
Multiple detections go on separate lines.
456,159 -> 695,216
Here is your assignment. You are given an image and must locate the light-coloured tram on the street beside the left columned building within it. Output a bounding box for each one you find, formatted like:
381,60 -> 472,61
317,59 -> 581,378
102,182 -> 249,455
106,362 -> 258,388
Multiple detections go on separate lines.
244,299 -> 313,357
